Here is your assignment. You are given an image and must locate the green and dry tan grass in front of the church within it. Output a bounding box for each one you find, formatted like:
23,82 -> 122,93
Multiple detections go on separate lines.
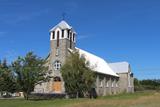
0,92 -> 160,107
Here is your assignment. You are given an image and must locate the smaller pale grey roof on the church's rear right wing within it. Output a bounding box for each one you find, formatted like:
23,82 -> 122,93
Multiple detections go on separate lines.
109,62 -> 130,73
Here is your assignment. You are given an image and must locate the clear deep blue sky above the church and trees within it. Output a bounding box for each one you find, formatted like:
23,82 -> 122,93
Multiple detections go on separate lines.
0,0 -> 160,79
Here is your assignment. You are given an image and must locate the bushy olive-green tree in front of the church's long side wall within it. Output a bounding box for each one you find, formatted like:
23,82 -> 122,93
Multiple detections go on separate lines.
61,52 -> 95,97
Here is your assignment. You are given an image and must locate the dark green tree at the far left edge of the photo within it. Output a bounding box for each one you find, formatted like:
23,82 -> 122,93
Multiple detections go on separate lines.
0,60 -> 16,94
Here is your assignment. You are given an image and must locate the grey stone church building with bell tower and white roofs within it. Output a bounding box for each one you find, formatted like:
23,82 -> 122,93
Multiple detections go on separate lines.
34,20 -> 134,96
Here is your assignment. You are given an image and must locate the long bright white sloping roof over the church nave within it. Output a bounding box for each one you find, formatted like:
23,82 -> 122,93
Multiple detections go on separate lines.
76,48 -> 118,77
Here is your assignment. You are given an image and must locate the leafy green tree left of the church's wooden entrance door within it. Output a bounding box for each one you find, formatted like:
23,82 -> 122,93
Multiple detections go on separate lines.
12,52 -> 50,100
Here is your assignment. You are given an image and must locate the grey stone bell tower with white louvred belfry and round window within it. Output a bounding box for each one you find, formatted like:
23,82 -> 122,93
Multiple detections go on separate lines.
50,20 -> 76,91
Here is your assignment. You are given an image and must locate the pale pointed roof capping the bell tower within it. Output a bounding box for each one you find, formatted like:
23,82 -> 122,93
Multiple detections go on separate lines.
50,20 -> 72,32
